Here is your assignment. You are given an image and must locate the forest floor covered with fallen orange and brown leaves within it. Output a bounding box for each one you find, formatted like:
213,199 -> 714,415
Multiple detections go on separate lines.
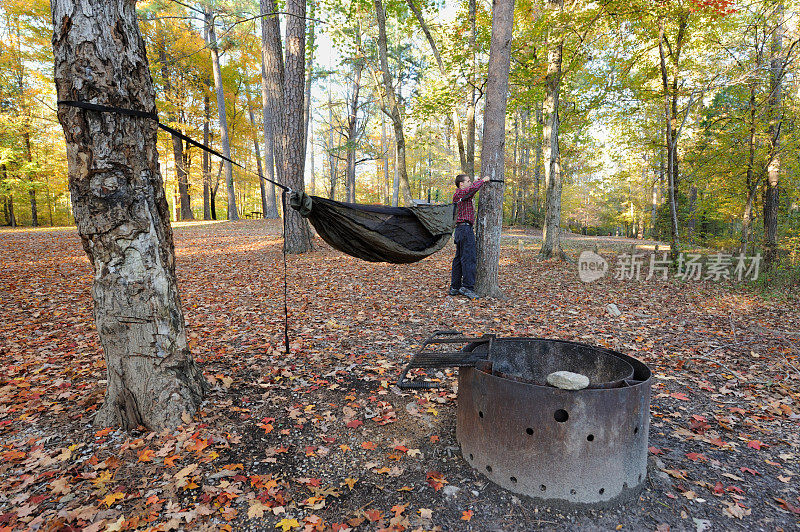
0,220 -> 800,531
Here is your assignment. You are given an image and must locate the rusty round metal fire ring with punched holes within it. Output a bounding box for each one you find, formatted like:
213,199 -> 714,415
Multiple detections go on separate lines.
456,338 -> 651,506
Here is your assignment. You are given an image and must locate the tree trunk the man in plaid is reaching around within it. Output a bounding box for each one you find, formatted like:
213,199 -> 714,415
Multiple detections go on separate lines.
475,0 -> 514,297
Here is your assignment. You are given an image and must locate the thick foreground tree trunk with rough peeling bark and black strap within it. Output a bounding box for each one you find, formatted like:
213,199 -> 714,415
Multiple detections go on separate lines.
51,0 -> 205,430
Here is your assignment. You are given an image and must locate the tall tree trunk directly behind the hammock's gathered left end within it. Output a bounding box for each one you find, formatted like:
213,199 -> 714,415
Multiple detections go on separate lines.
279,0 -> 312,253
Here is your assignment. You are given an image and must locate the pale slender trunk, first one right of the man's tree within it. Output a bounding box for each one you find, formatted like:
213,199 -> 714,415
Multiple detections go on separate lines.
540,0 -> 564,259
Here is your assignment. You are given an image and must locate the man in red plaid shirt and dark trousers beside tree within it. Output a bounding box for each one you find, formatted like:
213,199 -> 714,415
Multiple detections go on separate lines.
448,174 -> 489,299
